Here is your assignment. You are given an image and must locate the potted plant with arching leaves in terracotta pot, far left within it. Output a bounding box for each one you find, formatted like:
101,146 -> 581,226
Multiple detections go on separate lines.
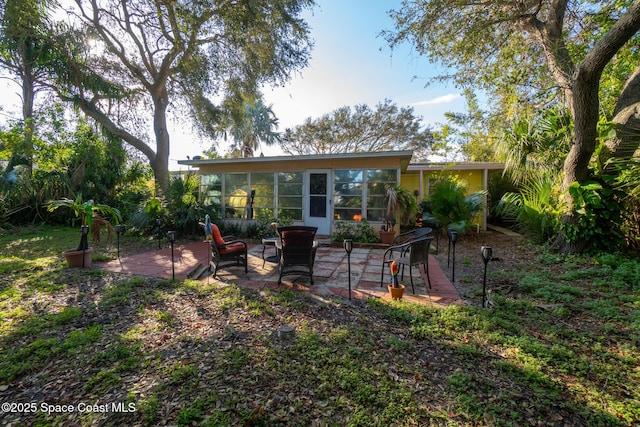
47,194 -> 120,268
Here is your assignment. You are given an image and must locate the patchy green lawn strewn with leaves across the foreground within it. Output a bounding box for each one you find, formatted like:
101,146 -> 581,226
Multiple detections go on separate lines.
0,227 -> 640,426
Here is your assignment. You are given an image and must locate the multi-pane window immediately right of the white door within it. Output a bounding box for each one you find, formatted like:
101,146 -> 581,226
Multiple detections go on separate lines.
333,169 -> 364,220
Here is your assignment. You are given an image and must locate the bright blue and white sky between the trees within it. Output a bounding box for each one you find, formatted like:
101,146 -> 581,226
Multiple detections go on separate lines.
0,0 -> 466,170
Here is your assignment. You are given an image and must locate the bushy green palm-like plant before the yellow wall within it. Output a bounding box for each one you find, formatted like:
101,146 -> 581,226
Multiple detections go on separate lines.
420,175 -> 484,232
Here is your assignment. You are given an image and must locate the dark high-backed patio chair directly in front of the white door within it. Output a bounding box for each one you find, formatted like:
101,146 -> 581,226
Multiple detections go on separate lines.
276,226 -> 318,285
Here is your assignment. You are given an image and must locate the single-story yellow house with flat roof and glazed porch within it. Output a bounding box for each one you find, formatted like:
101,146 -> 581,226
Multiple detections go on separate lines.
178,151 -> 503,235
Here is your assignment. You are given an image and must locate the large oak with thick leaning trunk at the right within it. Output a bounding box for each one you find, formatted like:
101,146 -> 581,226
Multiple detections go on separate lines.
387,0 -> 640,252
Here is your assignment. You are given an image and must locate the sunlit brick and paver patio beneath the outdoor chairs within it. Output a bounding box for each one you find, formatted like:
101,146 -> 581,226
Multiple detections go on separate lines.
94,242 -> 463,306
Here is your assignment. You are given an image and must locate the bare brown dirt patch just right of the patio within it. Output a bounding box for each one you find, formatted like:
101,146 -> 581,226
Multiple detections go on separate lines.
432,230 -> 539,305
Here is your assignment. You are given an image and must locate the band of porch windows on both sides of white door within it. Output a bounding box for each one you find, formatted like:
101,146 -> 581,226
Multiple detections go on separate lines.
200,168 -> 400,226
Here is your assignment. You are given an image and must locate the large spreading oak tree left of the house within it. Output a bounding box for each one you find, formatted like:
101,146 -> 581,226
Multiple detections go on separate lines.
47,0 -> 313,192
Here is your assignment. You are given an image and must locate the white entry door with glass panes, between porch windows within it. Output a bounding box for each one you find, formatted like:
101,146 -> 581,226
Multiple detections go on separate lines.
304,169 -> 332,235
